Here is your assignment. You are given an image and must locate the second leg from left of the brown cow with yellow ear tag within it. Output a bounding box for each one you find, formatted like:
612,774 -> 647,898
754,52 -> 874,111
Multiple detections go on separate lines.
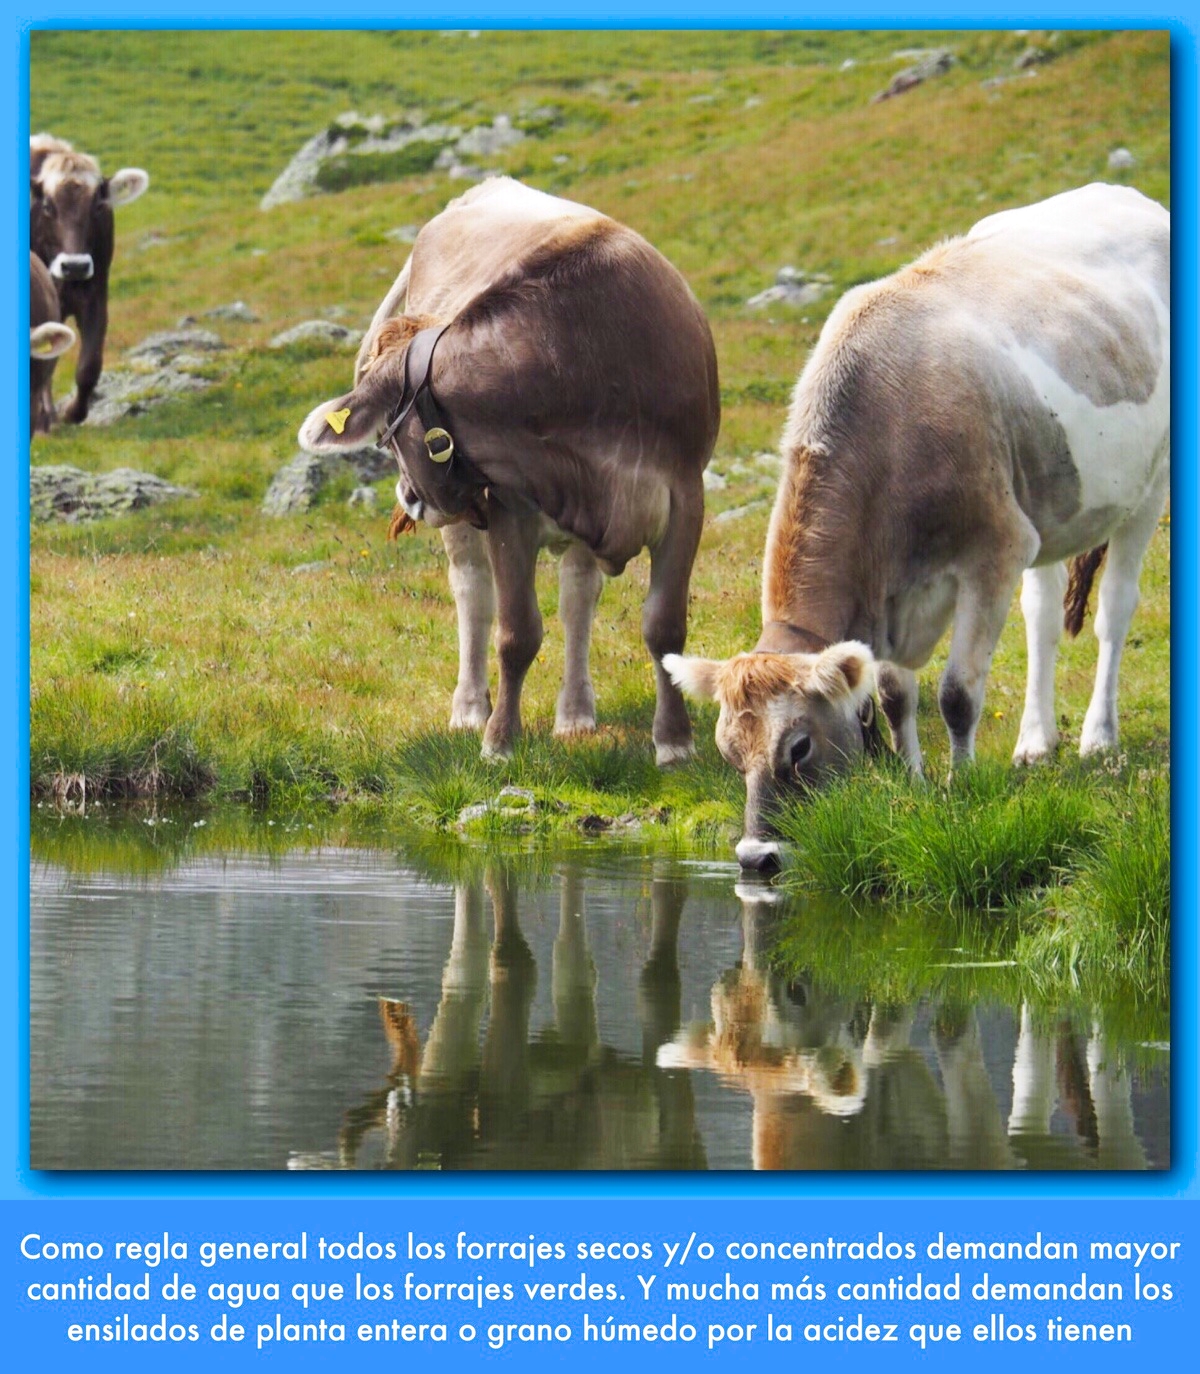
484,502 -> 542,758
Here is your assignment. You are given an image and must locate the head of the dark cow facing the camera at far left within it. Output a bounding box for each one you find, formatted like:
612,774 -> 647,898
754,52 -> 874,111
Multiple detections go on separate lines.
29,135 -> 150,290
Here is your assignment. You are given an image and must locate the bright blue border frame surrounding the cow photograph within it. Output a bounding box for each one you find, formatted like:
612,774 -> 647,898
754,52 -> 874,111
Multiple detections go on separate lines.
0,8 -> 1200,1202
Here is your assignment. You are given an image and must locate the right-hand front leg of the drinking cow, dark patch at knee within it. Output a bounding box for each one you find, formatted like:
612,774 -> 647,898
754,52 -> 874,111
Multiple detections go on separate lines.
937,530 -> 1039,769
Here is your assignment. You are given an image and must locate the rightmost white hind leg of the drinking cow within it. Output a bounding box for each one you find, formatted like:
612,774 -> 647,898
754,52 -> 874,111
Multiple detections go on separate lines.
1079,463 -> 1170,758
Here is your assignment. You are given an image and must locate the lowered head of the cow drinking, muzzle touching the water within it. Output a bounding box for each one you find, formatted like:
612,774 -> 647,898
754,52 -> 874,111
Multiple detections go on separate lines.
663,640 -> 876,868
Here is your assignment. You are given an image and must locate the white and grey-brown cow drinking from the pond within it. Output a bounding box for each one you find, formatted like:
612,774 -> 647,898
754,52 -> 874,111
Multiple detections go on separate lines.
664,184 -> 1171,868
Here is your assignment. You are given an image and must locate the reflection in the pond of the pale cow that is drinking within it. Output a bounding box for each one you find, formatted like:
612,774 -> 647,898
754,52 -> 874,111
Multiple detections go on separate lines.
658,885 -> 1146,1169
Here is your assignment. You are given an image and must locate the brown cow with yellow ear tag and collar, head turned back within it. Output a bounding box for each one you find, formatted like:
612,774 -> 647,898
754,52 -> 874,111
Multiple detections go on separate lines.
300,177 -> 719,764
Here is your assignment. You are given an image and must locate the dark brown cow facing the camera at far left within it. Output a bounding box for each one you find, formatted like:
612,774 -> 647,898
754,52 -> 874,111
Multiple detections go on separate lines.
29,133 -> 150,425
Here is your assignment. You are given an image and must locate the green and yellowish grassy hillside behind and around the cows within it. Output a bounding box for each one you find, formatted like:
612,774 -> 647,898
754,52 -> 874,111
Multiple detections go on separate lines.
30,32 -> 1170,857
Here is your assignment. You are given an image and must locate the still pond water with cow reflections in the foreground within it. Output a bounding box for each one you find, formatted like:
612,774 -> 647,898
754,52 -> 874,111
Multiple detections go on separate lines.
30,849 -> 1170,1169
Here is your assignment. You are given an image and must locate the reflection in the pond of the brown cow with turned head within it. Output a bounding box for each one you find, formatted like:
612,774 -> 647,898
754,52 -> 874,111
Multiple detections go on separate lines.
303,864 -> 705,1169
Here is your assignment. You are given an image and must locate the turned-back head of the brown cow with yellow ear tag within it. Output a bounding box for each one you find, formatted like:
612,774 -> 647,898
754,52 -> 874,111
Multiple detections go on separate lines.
298,315 -> 487,529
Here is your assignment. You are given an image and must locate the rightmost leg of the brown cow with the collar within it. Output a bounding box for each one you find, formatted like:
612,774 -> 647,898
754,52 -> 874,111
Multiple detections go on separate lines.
642,486 -> 704,767
